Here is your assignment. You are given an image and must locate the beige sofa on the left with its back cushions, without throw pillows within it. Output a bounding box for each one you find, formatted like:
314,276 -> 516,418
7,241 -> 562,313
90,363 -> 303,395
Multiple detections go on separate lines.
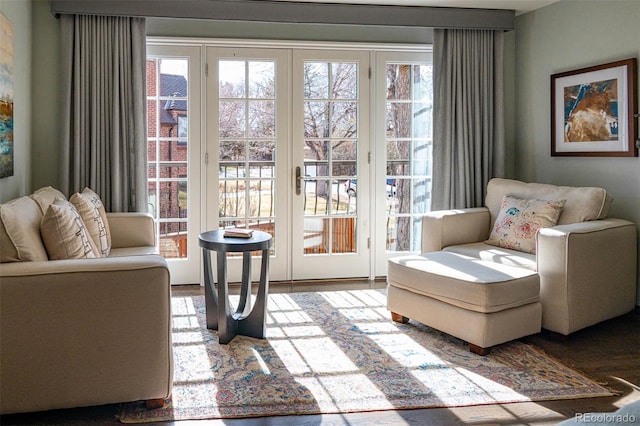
0,188 -> 173,414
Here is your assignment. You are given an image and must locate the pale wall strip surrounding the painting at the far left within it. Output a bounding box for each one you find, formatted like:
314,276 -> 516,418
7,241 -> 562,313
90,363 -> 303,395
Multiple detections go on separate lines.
0,0 -> 32,202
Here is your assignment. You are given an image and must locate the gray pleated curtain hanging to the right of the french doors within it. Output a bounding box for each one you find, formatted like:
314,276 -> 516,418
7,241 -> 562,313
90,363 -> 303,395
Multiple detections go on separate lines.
431,29 -> 504,210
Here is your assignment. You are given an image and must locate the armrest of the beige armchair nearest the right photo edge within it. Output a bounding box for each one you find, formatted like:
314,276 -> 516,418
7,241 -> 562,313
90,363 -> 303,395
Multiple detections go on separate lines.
536,218 -> 637,335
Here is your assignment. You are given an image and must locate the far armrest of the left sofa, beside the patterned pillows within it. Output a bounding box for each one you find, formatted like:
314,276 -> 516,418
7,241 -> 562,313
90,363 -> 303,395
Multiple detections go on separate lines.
107,213 -> 156,248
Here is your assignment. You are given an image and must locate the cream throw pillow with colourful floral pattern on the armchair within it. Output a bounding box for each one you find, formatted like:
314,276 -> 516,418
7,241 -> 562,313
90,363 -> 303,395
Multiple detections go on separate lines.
486,195 -> 565,254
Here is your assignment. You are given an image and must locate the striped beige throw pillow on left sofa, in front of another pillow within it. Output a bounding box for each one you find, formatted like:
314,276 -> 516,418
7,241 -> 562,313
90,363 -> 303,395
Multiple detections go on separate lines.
40,199 -> 100,260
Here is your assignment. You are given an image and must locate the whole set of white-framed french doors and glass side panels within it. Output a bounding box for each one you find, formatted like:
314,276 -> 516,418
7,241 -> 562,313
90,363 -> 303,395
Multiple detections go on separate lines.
147,41 -> 433,284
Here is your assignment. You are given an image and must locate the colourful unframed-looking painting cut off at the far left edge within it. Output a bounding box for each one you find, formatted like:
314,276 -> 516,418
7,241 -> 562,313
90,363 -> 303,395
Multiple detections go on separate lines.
0,13 -> 13,178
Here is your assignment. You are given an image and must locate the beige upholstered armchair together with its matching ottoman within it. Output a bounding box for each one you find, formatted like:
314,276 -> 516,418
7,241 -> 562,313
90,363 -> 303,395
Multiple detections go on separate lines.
387,179 -> 637,347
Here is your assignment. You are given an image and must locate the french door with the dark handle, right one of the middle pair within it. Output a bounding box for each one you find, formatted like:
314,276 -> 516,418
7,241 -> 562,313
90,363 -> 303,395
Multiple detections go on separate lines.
291,50 -> 370,279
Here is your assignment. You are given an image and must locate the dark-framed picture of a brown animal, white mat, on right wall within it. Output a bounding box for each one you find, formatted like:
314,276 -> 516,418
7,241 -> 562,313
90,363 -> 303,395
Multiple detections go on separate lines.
551,58 -> 638,157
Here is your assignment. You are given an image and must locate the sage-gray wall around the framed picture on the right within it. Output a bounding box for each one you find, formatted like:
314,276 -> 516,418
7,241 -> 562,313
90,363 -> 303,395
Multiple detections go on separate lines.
510,0 -> 640,305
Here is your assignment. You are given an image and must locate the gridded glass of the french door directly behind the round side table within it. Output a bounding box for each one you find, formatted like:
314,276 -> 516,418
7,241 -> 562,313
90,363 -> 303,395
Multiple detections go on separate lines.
218,59 -> 276,254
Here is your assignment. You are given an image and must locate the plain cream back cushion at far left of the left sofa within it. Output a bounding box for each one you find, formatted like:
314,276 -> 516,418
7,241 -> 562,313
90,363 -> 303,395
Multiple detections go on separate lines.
0,196 -> 47,262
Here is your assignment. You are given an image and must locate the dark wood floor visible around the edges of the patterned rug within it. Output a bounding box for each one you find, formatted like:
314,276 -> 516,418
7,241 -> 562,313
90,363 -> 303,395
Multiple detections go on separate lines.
0,282 -> 640,426
